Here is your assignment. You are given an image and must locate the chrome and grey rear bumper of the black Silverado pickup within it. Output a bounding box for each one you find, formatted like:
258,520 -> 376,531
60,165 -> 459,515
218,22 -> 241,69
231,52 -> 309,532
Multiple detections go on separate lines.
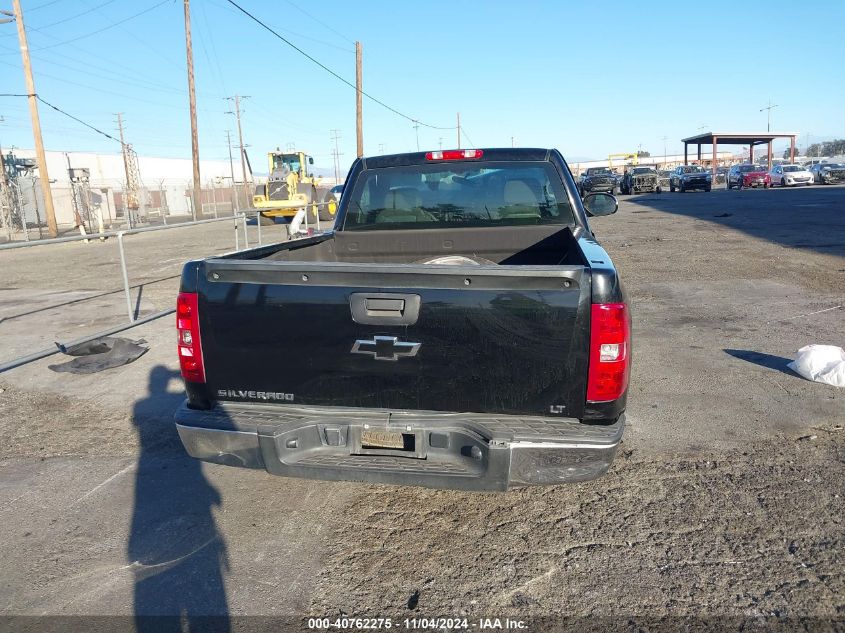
175,404 -> 625,490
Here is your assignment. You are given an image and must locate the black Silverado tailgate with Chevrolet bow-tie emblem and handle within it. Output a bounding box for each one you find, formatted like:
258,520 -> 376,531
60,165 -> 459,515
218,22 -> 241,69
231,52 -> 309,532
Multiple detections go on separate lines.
197,259 -> 590,418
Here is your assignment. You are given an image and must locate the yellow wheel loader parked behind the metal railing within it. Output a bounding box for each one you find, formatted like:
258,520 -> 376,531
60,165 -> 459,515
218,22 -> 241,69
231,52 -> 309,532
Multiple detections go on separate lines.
252,149 -> 337,223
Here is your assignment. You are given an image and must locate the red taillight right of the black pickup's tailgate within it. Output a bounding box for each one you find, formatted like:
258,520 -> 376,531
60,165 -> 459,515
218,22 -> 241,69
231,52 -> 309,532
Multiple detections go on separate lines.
587,303 -> 631,402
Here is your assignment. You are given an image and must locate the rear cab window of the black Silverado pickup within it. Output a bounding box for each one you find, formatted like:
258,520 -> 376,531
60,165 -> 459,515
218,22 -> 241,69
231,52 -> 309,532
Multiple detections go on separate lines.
343,161 -> 575,231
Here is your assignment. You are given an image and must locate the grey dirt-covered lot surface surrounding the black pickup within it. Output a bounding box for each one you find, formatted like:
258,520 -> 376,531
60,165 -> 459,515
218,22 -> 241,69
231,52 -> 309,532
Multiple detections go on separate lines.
0,187 -> 845,630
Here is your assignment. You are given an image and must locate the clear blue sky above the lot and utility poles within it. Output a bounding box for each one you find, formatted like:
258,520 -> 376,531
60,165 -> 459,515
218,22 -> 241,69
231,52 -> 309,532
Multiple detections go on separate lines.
0,0 -> 845,170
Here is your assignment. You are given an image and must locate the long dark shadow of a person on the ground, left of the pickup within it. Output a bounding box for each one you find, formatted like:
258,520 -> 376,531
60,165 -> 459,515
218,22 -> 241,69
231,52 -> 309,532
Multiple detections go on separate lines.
126,365 -> 231,633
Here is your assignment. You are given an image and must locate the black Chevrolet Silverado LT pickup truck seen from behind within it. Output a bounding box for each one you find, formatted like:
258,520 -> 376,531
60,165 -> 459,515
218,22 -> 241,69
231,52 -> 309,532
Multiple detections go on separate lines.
176,149 -> 631,490
